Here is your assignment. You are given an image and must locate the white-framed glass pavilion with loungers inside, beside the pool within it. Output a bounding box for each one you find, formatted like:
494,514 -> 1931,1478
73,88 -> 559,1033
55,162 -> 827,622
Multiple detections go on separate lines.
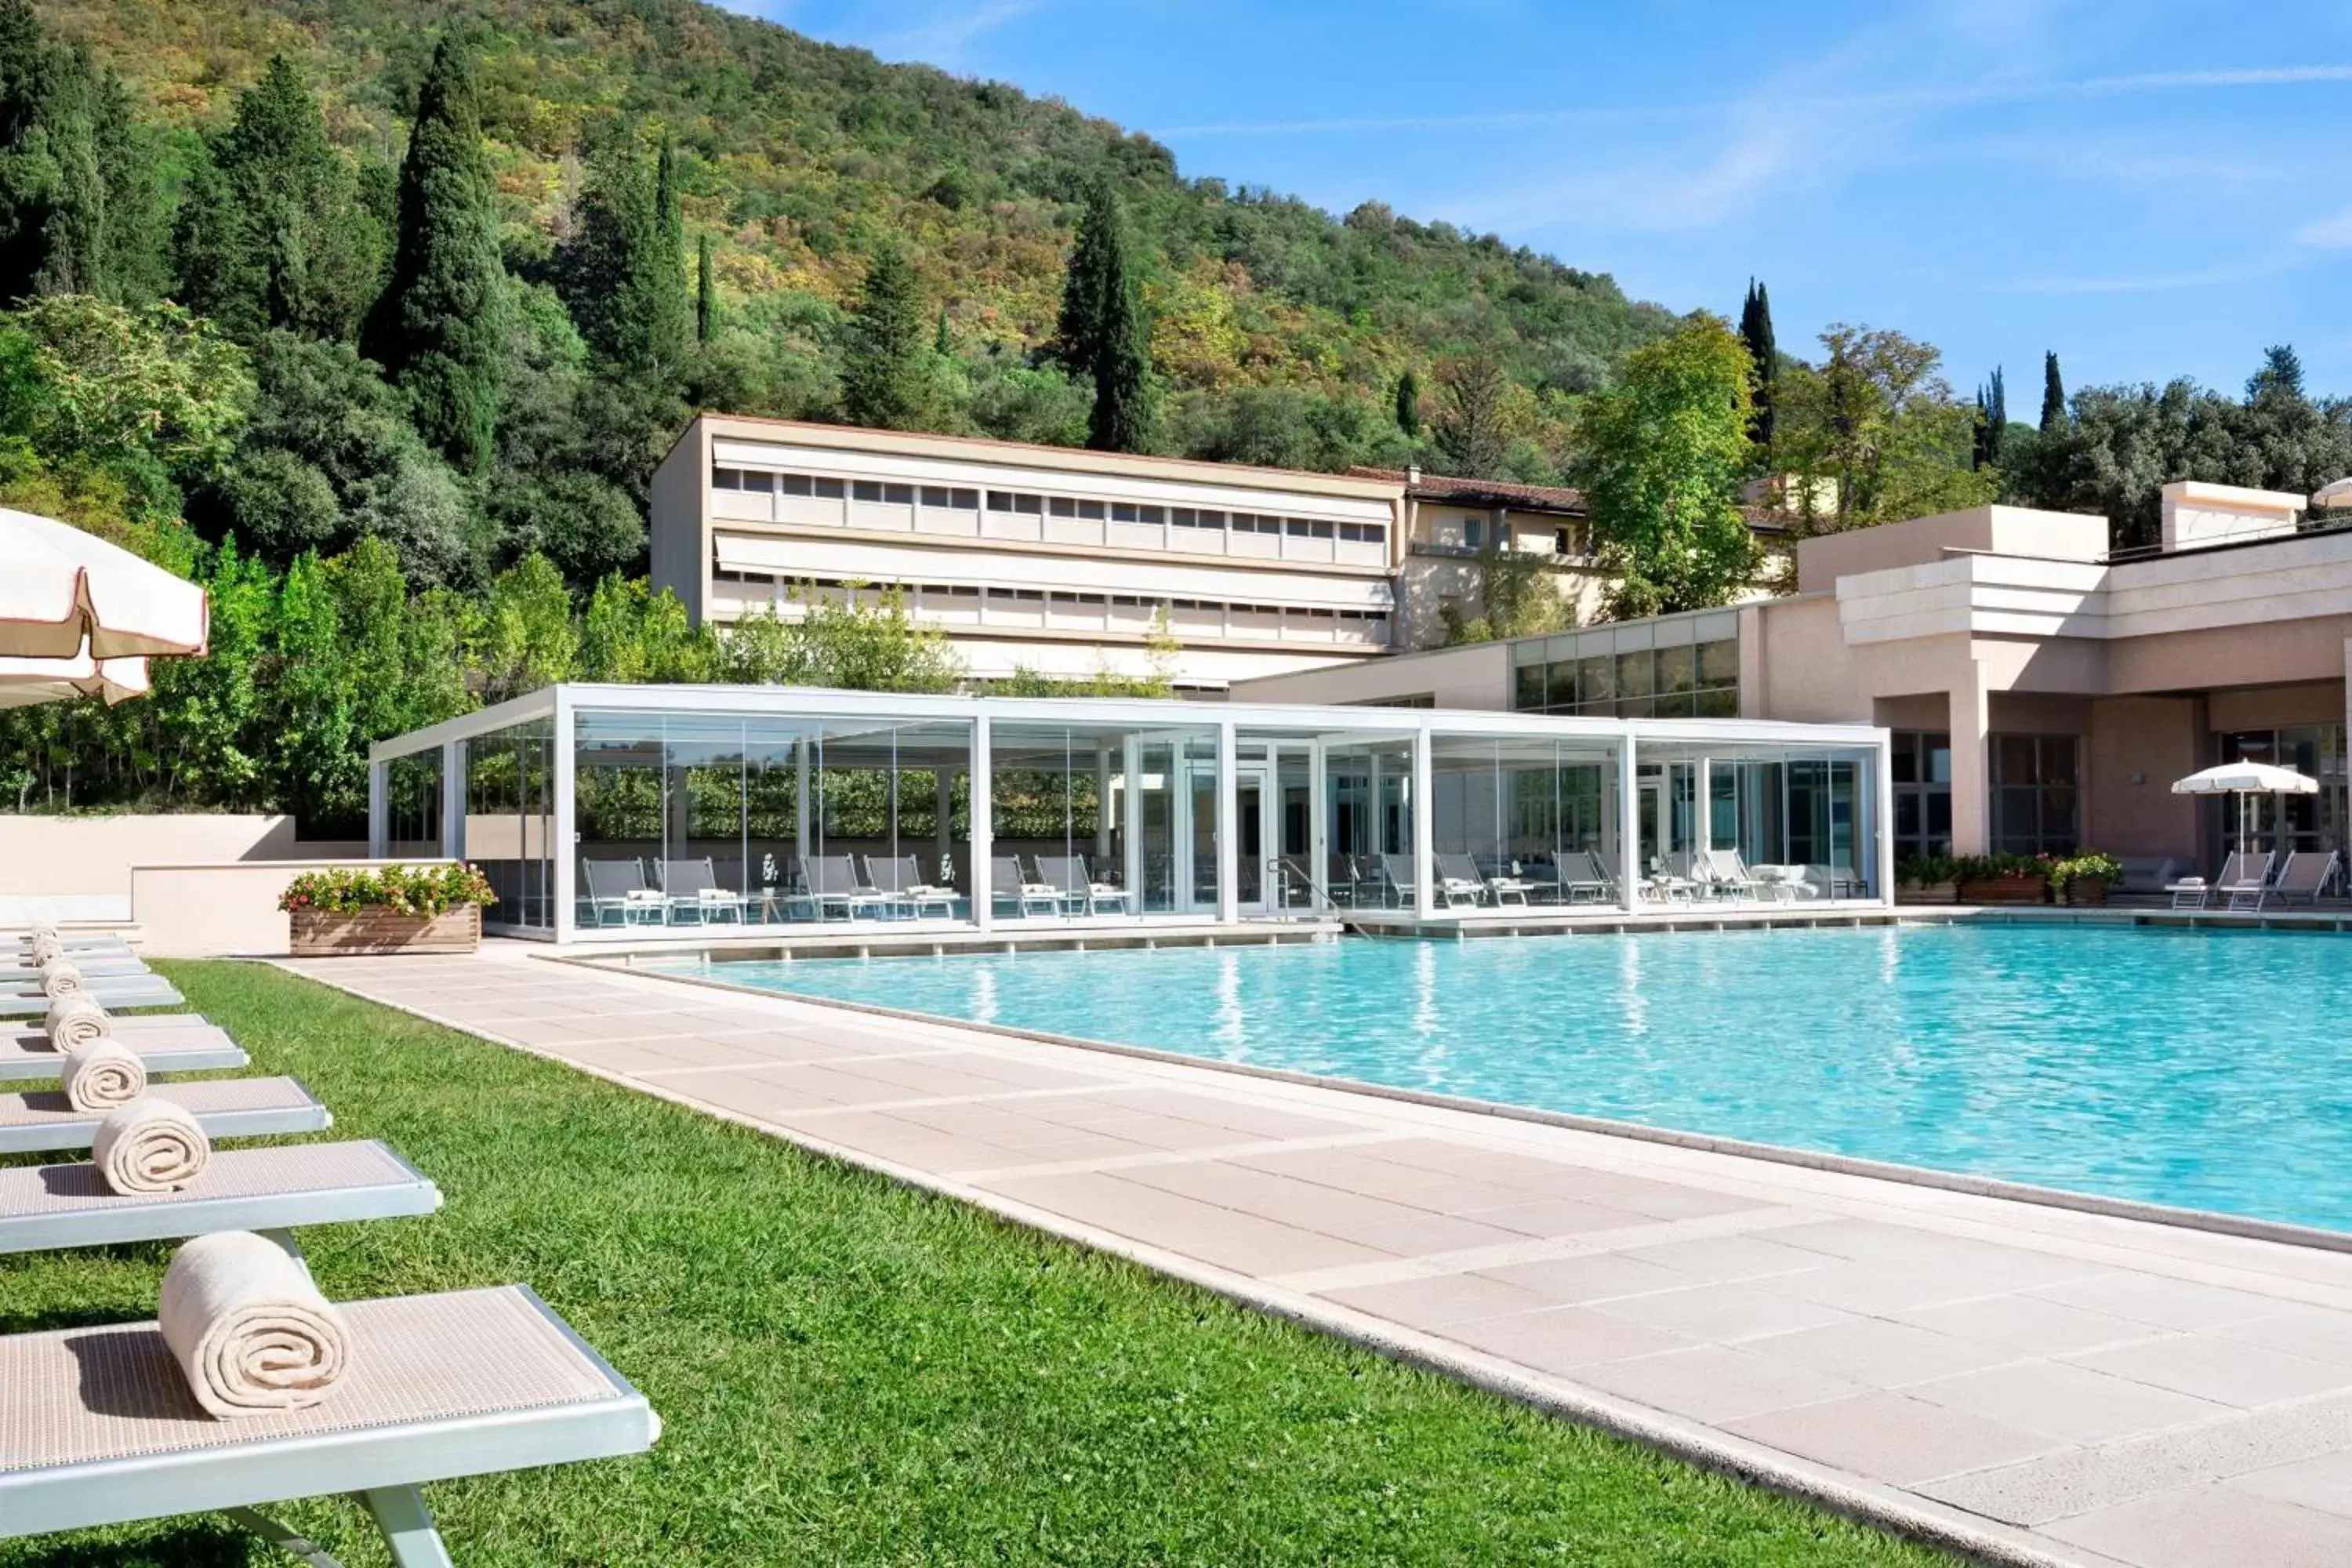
369,684 -> 1893,947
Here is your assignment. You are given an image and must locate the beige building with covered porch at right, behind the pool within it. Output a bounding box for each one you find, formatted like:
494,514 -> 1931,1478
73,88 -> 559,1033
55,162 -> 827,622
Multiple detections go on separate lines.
1237,482 -> 2352,869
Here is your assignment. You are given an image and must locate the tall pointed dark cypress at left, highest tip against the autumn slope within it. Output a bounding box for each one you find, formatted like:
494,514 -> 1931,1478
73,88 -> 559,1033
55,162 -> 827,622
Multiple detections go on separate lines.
362,38 -> 506,473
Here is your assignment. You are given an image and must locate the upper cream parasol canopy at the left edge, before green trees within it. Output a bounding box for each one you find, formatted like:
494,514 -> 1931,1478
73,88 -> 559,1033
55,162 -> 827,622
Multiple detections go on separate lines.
0,508 -> 207,661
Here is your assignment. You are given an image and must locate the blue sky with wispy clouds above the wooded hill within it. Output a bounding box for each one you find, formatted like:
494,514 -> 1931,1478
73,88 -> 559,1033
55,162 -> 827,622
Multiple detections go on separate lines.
731,0 -> 2352,399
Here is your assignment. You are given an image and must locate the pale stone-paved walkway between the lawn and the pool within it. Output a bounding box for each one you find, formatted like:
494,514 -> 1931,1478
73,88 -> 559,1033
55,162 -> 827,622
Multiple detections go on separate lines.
287,945 -> 2352,1568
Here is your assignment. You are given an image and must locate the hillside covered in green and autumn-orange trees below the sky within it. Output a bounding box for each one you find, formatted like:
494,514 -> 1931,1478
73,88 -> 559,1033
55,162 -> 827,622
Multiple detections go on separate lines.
40,0 -> 1672,477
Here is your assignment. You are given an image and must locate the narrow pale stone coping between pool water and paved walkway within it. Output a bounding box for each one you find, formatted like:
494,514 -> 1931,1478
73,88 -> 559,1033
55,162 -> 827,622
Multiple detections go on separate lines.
588,954 -> 2352,1253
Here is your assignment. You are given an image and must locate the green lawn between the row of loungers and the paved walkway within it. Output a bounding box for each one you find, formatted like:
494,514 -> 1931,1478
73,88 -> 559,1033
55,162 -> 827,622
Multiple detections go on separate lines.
0,964 -> 1943,1568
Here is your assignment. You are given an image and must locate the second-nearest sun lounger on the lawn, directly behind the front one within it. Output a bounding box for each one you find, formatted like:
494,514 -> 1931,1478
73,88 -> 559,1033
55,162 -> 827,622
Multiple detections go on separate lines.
0,1142 -> 440,1253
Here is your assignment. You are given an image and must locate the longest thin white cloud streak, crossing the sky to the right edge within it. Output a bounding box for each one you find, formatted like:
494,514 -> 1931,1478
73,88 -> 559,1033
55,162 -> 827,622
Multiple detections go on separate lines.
1152,64 -> 2352,139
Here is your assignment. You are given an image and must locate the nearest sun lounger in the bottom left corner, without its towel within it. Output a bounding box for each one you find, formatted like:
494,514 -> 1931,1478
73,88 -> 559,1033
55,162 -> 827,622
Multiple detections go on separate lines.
0,1286 -> 661,1568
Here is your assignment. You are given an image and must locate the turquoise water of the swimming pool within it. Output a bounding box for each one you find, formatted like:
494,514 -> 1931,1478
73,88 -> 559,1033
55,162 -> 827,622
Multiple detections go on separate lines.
668,924 -> 2352,1229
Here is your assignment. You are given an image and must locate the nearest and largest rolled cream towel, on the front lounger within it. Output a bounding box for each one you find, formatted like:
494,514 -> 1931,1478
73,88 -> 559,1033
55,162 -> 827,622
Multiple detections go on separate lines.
155,1229 -> 350,1420
